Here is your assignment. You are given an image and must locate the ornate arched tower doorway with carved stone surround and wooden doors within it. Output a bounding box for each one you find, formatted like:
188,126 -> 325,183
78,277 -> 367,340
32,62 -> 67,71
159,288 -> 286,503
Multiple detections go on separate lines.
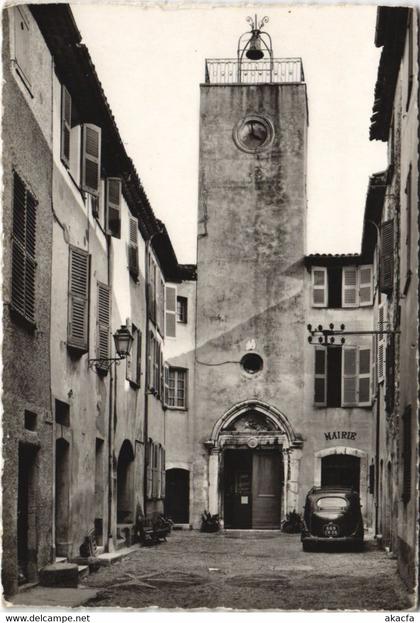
206,400 -> 302,529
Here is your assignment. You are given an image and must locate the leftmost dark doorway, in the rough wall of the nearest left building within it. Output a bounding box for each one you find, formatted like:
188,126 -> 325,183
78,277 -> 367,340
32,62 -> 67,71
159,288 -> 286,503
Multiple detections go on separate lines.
17,444 -> 37,584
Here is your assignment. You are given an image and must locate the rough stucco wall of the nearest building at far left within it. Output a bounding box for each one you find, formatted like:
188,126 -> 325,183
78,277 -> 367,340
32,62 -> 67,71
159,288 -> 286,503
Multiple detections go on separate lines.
2,9 -> 53,594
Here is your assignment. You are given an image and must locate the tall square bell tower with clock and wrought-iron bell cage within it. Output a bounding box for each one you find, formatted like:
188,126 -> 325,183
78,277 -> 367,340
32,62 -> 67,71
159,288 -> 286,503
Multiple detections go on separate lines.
192,16 -> 308,527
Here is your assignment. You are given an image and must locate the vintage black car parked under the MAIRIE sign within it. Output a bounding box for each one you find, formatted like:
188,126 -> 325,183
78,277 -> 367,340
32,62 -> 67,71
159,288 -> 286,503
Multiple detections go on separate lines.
301,487 -> 364,551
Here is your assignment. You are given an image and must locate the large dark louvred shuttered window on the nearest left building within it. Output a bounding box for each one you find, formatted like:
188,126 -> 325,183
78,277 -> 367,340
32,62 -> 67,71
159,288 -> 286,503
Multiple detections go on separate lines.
11,172 -> 37,324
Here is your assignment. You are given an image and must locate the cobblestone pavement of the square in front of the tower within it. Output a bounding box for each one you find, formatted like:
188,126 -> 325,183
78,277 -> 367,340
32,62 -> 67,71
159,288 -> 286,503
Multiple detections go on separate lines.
84,531 -> 410,610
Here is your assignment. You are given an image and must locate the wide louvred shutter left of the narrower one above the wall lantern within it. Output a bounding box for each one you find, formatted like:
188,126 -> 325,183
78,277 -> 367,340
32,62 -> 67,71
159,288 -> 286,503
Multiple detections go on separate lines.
67,247 -> 89,352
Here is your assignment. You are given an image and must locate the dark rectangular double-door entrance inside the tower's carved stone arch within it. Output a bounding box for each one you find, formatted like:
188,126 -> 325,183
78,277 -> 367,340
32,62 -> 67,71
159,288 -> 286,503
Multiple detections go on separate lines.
224,450 -> 283,530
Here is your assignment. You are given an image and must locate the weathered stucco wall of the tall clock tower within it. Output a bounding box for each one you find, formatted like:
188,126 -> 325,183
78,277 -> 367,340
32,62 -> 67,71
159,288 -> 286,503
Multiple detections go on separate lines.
193,84 -> 307,524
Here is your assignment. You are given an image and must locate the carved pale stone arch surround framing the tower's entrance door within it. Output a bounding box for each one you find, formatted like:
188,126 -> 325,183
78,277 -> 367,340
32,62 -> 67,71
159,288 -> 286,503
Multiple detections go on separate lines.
205,400 -> 303,516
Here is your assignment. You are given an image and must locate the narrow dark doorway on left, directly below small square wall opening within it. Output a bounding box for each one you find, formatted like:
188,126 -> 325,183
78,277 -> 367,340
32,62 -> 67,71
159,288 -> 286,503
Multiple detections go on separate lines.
55,439 -> 70,556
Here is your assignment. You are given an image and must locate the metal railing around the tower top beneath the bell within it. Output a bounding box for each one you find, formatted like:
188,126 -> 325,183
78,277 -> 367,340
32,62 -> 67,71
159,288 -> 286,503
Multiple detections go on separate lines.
206,58 -> 305,84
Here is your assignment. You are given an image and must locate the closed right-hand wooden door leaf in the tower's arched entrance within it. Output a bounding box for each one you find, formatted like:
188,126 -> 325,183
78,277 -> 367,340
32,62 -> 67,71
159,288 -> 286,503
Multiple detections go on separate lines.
252,450 -> 283,530
